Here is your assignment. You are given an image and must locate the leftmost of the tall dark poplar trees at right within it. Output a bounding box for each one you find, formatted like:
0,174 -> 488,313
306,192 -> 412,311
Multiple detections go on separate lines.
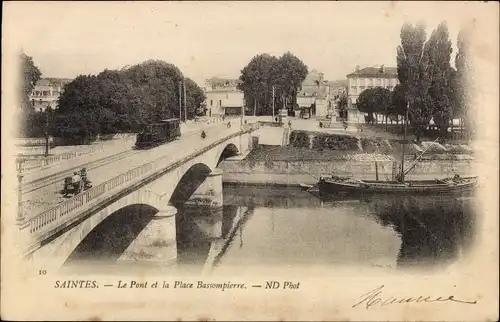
397,23 -> 432,141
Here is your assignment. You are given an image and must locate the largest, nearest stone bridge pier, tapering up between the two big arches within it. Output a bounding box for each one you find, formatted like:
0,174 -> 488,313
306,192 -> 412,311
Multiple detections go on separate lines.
118,206 -> 177,265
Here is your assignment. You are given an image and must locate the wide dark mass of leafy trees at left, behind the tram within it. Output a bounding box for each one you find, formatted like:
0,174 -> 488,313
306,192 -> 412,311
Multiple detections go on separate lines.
20,54 -> 205,143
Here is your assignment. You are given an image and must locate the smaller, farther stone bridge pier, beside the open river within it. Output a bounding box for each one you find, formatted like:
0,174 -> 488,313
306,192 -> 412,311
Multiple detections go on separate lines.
186,169 -> 223,208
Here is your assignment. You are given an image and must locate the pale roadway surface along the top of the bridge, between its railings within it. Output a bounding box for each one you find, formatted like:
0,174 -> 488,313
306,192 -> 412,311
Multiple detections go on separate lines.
23,120 -> 245,217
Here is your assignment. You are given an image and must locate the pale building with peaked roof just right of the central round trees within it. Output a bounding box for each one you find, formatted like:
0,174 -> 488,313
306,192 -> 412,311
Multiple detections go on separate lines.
297,69 -> 331,116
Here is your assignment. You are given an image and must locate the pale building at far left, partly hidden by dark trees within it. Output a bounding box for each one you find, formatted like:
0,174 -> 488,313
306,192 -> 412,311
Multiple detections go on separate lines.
29,78 -> 72,112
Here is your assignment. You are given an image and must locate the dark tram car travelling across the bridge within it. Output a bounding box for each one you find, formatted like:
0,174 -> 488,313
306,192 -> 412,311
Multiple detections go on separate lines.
135,118 -> 181,149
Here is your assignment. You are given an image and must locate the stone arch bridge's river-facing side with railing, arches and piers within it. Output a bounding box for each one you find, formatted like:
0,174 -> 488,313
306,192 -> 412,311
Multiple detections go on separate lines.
19,124 -> 257,270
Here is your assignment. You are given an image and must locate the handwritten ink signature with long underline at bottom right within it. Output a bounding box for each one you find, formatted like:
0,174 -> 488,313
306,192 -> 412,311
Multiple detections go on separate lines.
352,285 -> 477,310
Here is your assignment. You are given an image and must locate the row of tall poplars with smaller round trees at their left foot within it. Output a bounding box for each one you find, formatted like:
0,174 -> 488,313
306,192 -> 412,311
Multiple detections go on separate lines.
350,22 -> 473,140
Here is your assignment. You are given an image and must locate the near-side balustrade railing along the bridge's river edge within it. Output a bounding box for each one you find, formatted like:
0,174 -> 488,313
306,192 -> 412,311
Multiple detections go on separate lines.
22,124 -> 258,245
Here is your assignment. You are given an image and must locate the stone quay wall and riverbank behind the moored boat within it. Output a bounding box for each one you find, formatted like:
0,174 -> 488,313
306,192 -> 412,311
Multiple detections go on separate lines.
219,147 -> 476,186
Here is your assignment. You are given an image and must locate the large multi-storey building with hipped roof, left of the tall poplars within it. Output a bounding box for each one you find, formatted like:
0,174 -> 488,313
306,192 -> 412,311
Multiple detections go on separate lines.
347,65 -> 399,122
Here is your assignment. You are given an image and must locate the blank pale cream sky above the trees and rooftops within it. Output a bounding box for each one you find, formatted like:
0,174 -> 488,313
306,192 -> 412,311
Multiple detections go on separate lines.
4,2 -> 488,85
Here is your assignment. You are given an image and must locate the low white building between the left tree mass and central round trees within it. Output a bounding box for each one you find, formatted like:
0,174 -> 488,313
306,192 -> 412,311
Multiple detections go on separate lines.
205,77 -> 244,116
